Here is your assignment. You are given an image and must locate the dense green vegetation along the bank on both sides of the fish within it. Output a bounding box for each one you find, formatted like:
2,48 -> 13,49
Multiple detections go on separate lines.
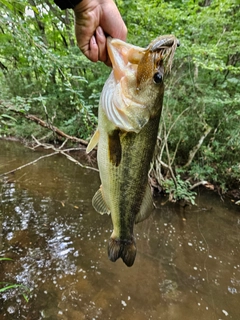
0,0 -> 240,197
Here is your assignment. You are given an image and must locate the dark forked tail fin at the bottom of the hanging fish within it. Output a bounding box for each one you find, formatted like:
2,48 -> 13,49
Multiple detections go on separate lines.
108,238 -> 137,267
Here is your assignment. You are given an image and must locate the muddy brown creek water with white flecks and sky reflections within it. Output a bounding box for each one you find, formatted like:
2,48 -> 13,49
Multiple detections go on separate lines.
0,140 -> 240,320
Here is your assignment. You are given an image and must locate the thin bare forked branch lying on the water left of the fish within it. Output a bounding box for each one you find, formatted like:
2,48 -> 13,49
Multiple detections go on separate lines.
0,136 -> 99,177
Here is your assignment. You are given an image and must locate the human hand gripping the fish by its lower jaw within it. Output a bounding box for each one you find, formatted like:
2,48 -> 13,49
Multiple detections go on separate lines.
74,0 -> 127,66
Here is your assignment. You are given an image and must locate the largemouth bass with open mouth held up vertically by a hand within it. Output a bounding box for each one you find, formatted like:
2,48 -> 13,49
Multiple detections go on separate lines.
86,35 -> 179,267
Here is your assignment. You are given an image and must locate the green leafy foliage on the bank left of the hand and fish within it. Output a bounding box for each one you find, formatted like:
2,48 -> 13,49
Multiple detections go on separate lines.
0,0 -> 106,138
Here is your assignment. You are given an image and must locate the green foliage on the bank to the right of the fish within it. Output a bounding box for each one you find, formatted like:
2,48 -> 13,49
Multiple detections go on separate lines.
118,0 -> 240,191
